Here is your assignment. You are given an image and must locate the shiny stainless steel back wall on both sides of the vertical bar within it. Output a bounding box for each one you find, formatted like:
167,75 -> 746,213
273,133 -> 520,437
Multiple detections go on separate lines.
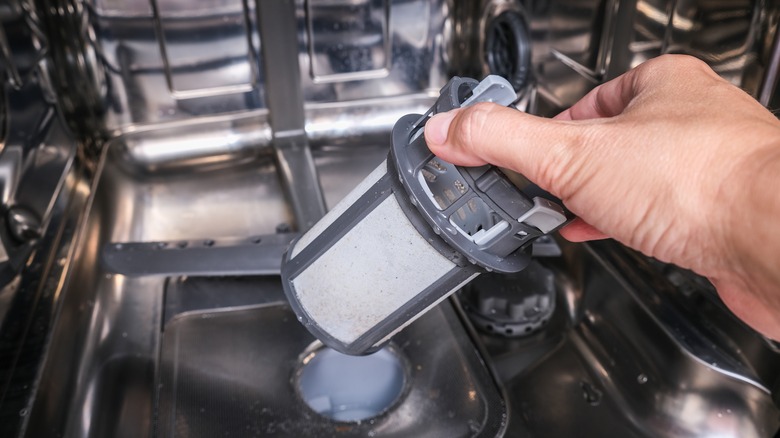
22,0 -> 780,159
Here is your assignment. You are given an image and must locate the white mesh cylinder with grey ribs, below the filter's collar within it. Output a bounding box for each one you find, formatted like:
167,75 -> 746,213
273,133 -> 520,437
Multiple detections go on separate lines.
283,161 -> 478,354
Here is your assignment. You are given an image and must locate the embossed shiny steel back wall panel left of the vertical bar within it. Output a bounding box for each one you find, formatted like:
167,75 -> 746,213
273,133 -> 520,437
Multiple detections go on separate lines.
79,0 -> 265,132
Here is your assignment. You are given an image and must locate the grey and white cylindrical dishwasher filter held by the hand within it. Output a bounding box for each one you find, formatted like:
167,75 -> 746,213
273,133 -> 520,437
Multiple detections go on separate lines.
282,76 -> 568,354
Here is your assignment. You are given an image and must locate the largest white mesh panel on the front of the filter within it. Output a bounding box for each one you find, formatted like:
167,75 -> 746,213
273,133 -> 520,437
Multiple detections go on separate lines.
293,196 -> 455,343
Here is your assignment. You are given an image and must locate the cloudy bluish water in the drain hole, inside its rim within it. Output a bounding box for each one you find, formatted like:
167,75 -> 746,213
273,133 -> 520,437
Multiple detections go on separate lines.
295,347 -> 406,421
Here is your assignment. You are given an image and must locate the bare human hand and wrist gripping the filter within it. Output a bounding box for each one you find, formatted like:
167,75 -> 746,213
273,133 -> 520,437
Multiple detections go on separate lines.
425,55 -> 780,340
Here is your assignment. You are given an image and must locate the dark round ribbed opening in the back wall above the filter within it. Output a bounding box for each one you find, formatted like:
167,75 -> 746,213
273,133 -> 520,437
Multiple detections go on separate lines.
485,11 -> 531,90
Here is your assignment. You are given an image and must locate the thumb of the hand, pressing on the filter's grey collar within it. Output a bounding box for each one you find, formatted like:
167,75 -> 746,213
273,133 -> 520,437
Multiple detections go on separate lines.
425,103 -> 592,201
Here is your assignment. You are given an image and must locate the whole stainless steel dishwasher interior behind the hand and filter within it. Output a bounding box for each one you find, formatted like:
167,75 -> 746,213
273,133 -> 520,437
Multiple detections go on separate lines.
0,0 -> 780,437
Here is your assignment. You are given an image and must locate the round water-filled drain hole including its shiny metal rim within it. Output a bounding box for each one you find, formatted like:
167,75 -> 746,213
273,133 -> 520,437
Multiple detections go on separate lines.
291,341 -> 411,424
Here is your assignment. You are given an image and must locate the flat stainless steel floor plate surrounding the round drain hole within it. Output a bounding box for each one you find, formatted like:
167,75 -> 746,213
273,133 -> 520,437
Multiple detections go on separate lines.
157,302 -> 506,437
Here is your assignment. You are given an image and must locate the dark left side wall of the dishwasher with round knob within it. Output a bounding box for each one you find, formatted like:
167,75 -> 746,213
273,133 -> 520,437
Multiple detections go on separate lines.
0,7 -> 86,436
